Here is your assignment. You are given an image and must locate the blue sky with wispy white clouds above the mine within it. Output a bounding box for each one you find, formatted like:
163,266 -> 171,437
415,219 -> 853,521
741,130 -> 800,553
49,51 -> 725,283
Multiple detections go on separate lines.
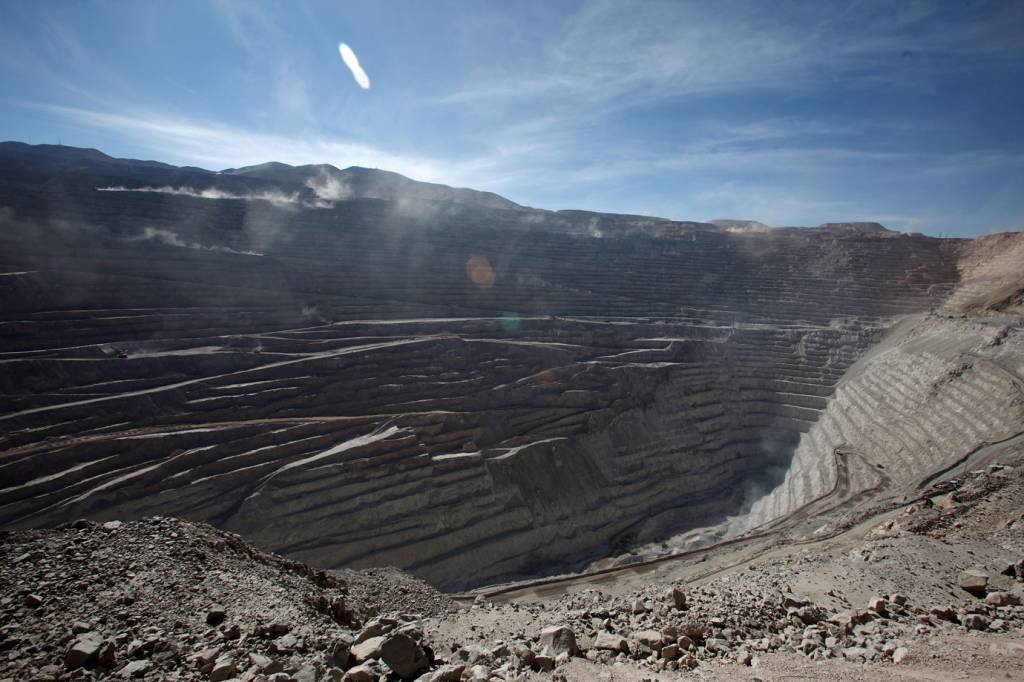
0,0 -> 1024,236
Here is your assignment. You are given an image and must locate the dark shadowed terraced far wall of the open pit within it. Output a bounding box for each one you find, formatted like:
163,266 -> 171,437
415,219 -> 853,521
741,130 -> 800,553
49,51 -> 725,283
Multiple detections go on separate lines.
0,161 -> 974,589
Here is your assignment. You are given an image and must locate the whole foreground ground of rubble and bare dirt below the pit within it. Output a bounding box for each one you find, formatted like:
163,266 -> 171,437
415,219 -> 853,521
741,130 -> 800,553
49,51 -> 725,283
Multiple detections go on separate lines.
0,446 -> 1024,682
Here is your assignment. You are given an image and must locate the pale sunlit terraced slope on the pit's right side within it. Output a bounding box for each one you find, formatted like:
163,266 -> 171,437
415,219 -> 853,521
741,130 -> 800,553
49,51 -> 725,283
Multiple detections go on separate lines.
732,313 -> 1024,532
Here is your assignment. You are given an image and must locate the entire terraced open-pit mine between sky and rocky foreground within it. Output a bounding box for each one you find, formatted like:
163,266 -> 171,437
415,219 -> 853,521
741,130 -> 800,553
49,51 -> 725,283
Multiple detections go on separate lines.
0,142 -> 1024,679
